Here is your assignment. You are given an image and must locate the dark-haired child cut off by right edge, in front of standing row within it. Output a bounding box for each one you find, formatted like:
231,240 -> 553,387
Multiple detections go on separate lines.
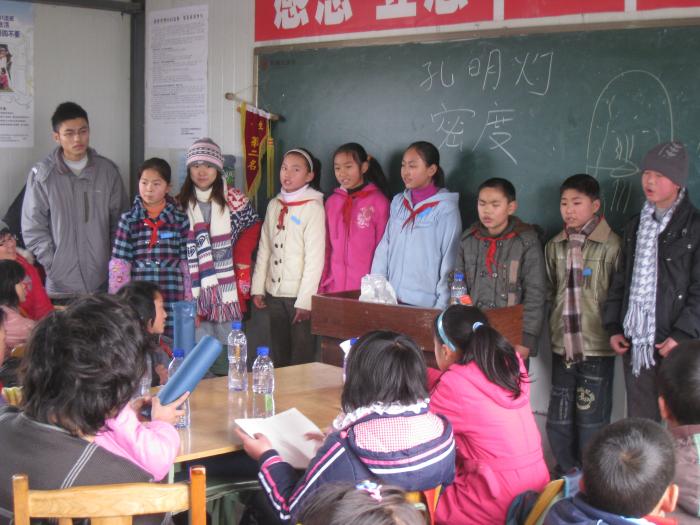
658,341 -> 700,523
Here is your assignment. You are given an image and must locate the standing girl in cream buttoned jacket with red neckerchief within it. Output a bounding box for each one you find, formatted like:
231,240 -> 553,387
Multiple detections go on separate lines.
251,148 -> 326,367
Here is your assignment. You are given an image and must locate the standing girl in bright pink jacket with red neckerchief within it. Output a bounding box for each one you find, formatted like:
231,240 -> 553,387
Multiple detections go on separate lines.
319,142 -> 389,293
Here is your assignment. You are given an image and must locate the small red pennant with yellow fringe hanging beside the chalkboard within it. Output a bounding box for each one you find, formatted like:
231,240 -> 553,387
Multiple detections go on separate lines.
240,104 -> 274,198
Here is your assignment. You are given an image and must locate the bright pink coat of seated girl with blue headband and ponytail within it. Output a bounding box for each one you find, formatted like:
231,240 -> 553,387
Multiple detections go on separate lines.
428,361 -> 549,525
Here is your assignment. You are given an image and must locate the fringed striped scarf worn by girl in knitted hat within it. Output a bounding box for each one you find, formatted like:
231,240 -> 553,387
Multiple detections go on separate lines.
187,189 -> 241,323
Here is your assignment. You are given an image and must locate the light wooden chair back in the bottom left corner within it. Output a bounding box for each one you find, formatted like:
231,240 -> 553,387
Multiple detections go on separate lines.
12,466 -> 206,525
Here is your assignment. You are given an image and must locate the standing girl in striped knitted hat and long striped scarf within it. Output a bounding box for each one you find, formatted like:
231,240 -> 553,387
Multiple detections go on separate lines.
178,138 -> 260,375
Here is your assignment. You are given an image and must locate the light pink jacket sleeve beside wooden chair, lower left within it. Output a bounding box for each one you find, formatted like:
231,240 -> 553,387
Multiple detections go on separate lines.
95,404 -> 180,481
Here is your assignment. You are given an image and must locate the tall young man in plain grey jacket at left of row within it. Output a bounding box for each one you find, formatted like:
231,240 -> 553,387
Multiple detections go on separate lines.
22,102 -> 128,303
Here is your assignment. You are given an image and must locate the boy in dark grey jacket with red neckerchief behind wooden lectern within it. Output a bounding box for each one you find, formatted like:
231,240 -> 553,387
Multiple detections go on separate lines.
455,178 -> 547,359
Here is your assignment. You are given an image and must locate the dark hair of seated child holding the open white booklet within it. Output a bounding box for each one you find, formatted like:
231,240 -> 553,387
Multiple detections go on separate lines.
340,330 -> 428,412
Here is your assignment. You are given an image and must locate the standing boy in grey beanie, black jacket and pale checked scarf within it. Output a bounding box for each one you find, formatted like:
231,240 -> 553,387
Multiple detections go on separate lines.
603,142 -> 700,421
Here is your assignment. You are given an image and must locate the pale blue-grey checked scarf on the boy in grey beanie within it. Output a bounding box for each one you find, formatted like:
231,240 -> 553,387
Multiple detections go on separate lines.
622,189 -> 685,376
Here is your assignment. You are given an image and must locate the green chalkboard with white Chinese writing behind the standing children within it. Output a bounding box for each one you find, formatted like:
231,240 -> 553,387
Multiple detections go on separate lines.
258,27 -> 700,235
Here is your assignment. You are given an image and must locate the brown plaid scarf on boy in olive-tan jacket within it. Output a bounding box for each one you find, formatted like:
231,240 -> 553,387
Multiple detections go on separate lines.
562,215 -> 600,363
